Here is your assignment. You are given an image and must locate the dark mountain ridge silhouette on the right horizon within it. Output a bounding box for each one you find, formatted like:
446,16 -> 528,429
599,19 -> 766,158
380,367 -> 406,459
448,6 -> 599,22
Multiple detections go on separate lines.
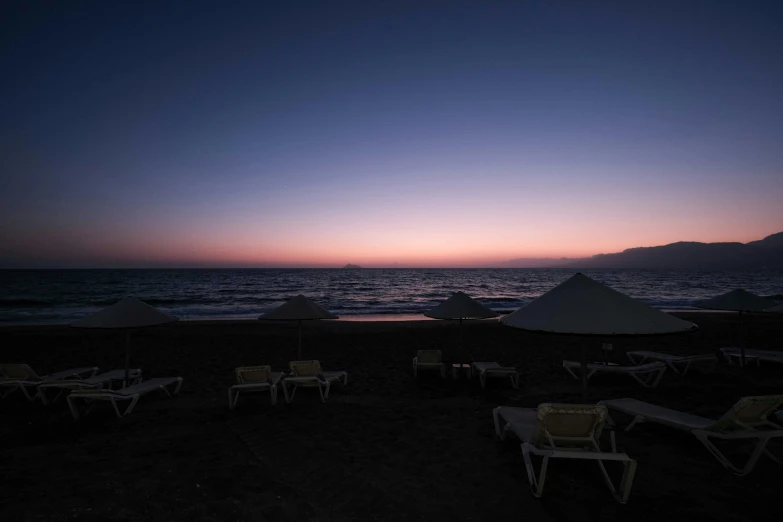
504,232 -> 783,270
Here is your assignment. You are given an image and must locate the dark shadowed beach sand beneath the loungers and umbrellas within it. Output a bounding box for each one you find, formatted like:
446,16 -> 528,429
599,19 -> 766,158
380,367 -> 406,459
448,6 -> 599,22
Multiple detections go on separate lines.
0,313 -> 783,521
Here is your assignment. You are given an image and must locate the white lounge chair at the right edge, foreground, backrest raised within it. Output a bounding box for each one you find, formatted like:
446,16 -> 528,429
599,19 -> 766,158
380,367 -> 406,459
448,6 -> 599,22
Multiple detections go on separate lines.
599,395 -> 783,475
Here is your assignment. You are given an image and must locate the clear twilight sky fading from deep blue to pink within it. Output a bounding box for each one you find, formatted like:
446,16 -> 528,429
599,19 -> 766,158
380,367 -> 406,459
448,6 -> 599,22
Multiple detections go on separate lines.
0,0 -> 783,268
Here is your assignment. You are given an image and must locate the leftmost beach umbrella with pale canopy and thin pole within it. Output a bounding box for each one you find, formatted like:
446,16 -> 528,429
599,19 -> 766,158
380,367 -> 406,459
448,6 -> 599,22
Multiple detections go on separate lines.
71,297 -> 178,385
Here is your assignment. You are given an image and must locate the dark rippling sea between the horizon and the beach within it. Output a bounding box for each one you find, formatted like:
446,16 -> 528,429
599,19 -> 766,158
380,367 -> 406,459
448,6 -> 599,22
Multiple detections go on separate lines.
0,268 -> 783,325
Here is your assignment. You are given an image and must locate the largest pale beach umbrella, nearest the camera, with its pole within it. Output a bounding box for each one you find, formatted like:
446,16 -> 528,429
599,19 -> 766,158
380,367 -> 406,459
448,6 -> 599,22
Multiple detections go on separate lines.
500,273 -> 697,397
